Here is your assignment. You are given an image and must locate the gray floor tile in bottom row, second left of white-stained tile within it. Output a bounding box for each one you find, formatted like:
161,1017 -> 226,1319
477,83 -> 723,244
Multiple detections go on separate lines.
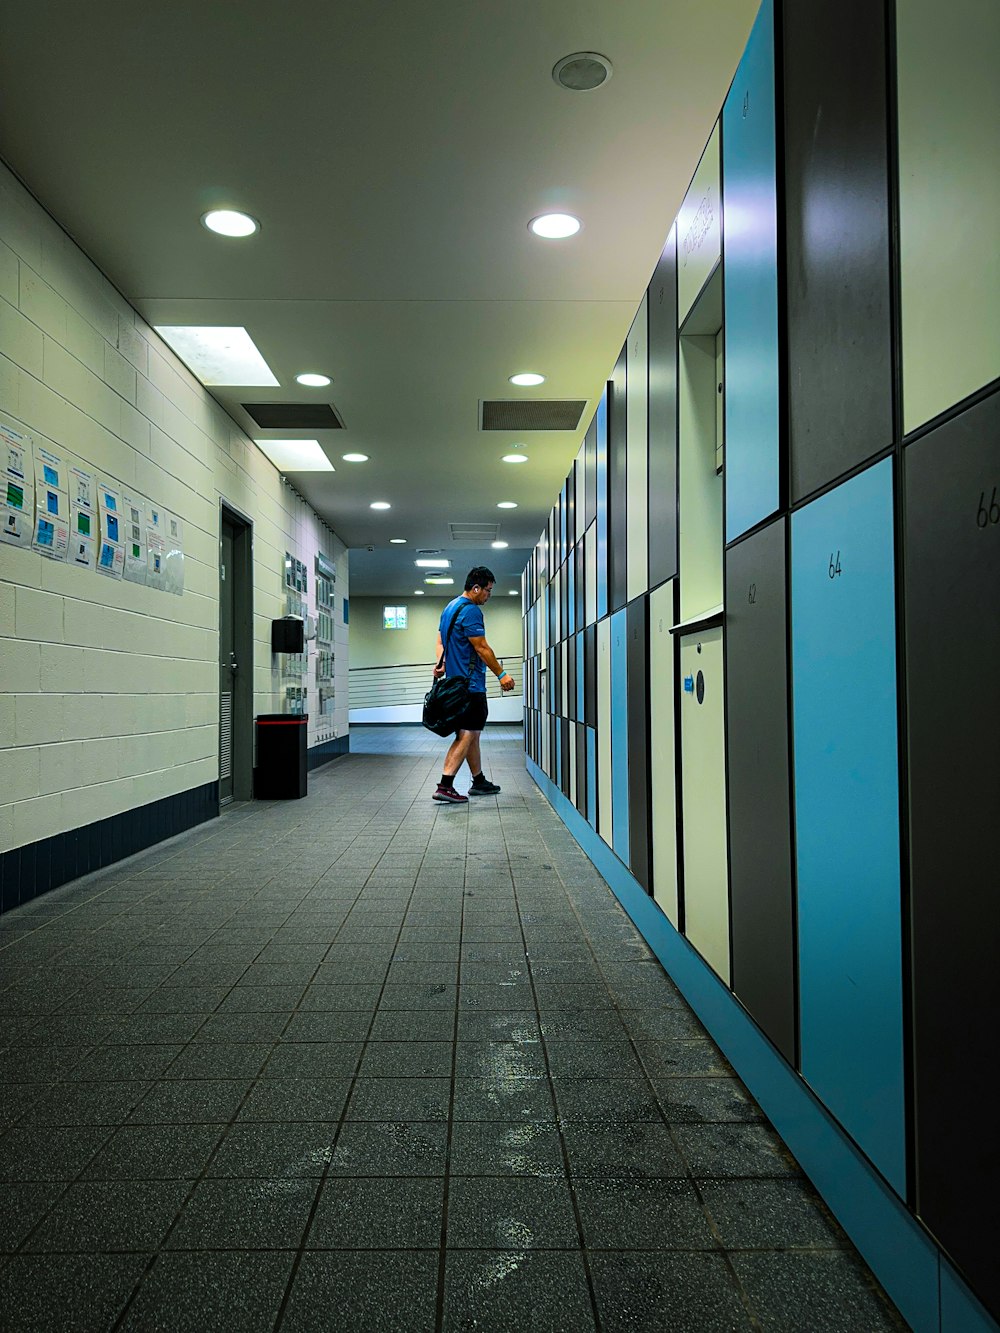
121,1250 -> 293,1333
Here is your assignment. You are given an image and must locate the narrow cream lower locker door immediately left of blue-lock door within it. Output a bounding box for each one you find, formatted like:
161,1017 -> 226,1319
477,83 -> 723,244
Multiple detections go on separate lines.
649,579 -> 680,926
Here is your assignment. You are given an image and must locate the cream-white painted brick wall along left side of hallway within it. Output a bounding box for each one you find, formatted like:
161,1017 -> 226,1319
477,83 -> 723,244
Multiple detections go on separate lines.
0,167 -> 348,852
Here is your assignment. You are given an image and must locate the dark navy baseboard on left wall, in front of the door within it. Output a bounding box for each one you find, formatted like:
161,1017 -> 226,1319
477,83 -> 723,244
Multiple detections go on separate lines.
0,782 -> 219,912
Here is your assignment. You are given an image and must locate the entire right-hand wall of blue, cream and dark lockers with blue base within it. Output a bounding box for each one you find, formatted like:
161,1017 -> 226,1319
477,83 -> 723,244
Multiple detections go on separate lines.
525,0 -> 1000,1333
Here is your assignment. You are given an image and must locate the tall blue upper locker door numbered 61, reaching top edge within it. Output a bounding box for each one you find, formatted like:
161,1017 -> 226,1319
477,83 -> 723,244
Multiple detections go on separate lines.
723,0 -> 780,541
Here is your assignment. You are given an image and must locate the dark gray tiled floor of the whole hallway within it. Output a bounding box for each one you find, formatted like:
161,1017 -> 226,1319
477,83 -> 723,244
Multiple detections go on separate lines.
0,729 -> 904,1333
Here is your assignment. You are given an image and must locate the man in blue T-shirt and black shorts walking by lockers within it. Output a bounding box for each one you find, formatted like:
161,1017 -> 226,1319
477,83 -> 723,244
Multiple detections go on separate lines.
433,565 -> 513,805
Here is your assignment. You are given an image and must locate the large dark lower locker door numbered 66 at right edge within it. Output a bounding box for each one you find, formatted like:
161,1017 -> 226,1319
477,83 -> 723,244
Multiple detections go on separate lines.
903,393 -> 1000,1316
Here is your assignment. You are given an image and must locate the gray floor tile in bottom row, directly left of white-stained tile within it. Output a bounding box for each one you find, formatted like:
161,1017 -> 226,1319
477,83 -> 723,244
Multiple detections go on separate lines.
281,1250 -> 437,1333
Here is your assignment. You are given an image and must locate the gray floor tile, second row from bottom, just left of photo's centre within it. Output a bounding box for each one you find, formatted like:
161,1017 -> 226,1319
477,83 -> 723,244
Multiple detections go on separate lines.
307,1176 -> 444,1250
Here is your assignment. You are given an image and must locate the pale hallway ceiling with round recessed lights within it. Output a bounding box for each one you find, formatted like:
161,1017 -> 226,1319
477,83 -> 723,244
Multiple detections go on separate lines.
0,0 -> 756,595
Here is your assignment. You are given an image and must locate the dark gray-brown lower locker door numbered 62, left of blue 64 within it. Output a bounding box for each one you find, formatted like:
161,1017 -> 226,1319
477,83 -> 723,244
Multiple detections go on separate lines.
725,519 -> 796,1065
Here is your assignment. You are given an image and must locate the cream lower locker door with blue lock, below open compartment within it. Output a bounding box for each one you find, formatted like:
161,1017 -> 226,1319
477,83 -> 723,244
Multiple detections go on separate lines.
680,628 -> 729,985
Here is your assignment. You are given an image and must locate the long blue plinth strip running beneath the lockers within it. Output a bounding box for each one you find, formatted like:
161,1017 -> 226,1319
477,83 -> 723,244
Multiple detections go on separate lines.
525,756 -> 997,1333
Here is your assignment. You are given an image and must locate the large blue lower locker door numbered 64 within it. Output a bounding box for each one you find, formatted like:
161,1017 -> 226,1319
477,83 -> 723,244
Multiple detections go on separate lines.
792,459 -> 905,1194
